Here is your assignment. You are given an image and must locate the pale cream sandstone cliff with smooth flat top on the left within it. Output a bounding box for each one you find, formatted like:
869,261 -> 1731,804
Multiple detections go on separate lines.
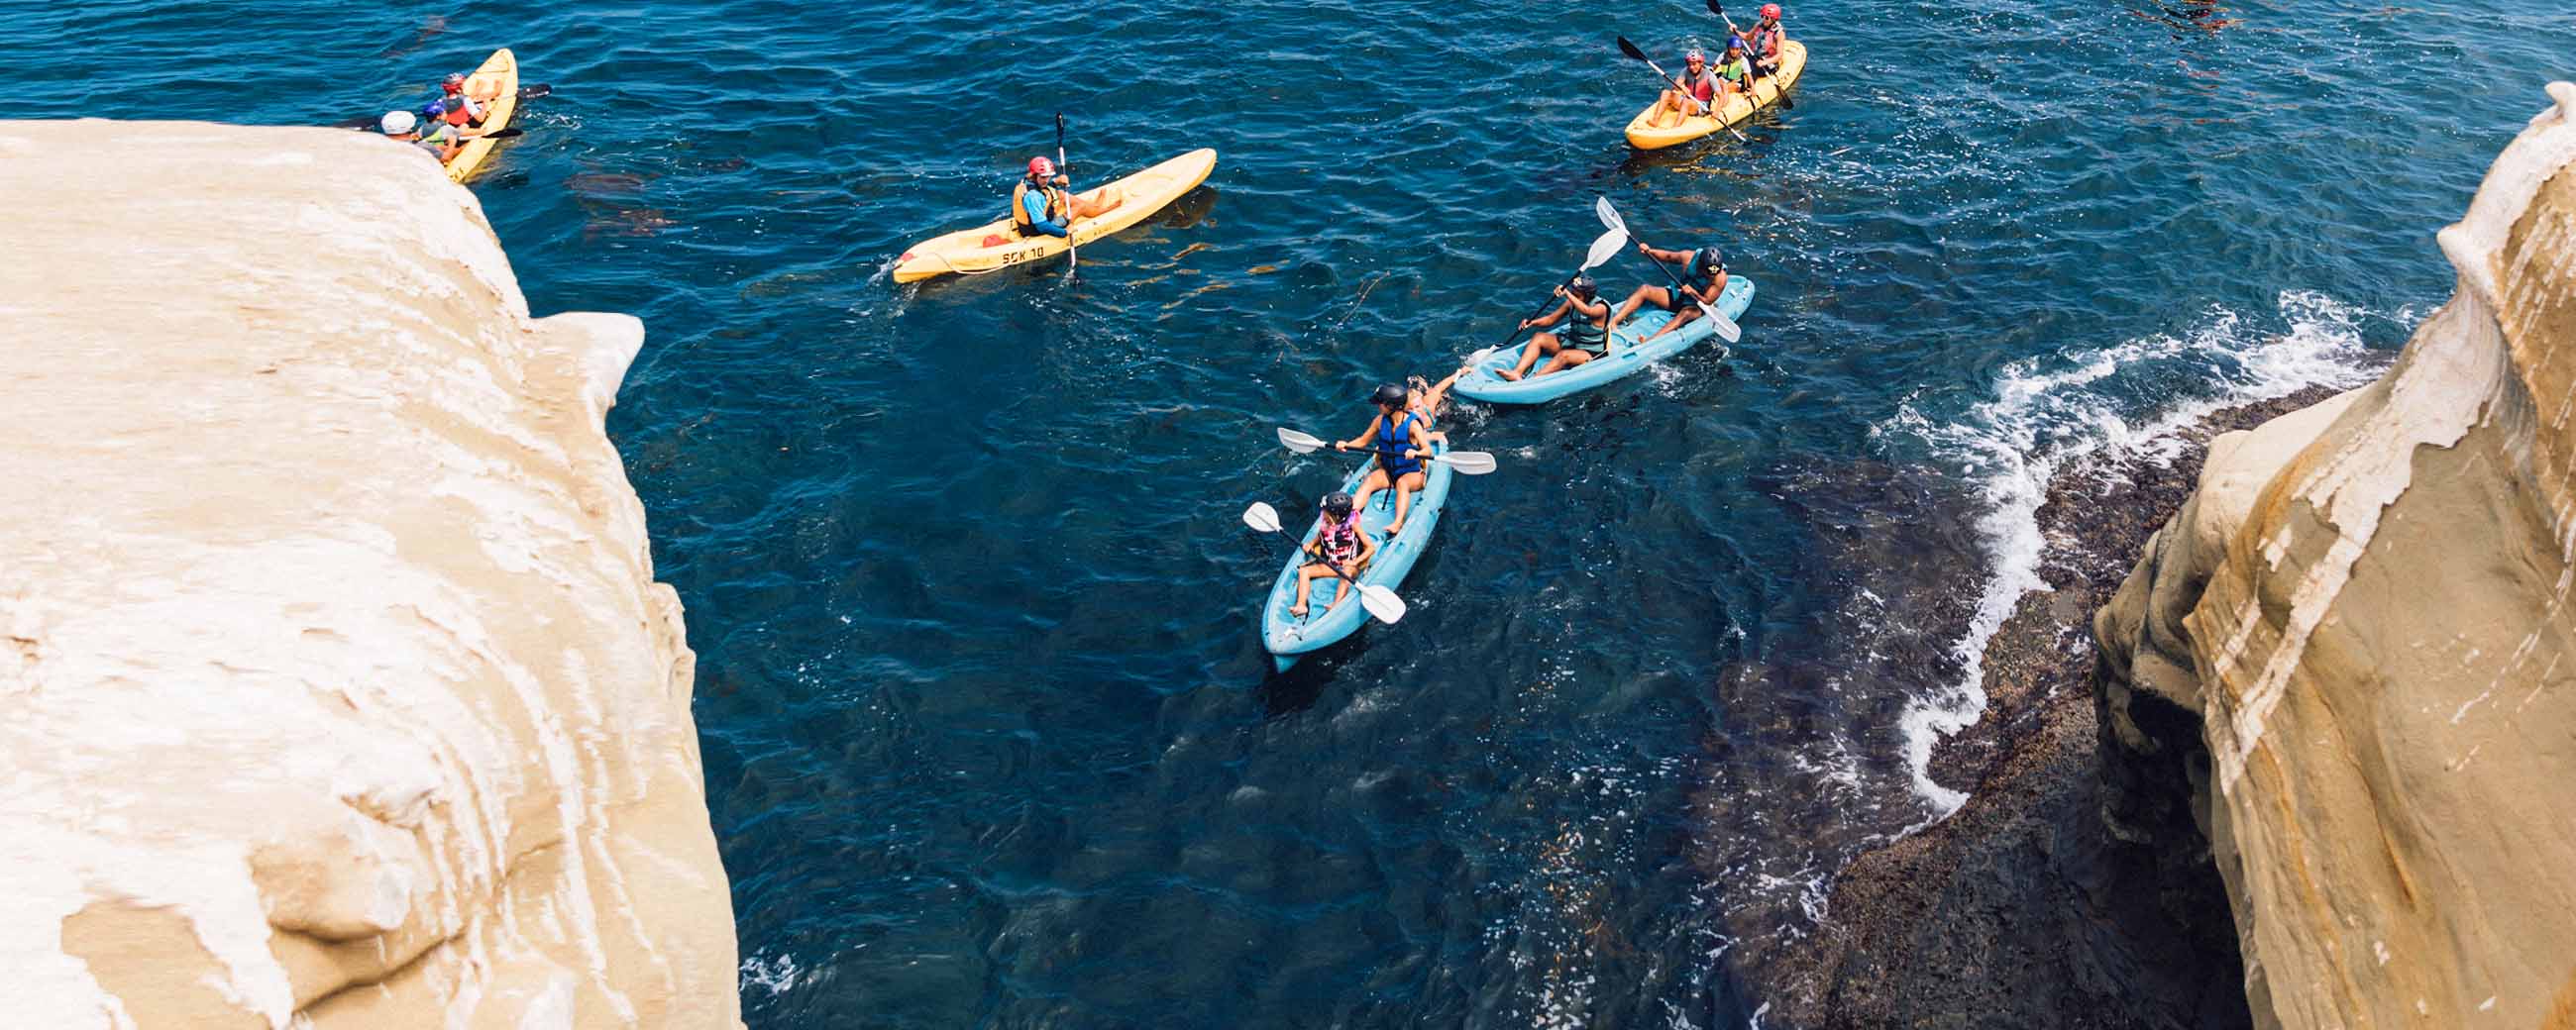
0,121 -> 739,1027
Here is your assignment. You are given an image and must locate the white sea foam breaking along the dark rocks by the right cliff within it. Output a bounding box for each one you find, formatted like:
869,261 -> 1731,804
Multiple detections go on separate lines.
1876,291 -> 2412,824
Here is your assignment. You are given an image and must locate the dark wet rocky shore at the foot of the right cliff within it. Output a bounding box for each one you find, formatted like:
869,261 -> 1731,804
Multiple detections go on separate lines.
1760,386 -> 2336,1030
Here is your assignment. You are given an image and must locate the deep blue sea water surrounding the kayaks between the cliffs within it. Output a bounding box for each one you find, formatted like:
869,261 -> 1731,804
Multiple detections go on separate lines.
25,0 -> 2576,1027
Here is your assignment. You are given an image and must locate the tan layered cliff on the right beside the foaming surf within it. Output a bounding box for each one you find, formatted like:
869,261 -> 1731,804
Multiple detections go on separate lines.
2094,82 -> 2576,1027
